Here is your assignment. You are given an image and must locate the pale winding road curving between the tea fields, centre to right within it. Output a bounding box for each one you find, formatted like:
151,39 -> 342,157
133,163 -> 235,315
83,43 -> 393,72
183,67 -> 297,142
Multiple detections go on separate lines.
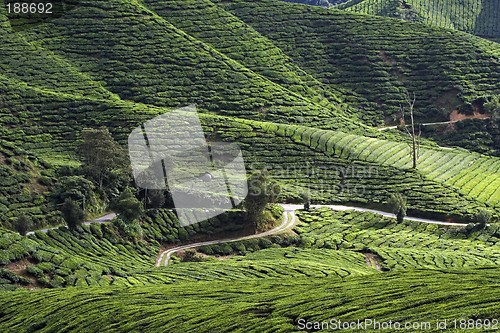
155,204 -> 467,267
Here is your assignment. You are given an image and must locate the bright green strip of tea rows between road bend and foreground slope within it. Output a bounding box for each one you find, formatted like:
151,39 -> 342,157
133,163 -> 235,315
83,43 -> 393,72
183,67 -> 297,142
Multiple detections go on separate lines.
111,248 -> 377,286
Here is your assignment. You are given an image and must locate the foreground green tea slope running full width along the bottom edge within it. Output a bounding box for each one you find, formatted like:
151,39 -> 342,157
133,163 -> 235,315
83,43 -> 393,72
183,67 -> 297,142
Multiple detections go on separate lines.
0,269 -> 500,332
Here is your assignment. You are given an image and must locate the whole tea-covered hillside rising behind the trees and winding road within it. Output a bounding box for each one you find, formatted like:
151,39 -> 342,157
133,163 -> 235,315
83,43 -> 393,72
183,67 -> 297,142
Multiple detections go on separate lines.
0,0 -> 500,225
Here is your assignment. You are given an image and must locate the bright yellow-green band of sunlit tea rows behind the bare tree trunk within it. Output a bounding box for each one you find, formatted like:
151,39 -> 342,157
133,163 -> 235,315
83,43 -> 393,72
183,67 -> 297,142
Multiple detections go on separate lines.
250,120 -> 500,207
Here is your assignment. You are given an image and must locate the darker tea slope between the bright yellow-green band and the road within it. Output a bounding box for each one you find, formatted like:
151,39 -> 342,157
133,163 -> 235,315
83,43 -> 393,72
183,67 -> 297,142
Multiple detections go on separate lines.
202,117 -> 483,216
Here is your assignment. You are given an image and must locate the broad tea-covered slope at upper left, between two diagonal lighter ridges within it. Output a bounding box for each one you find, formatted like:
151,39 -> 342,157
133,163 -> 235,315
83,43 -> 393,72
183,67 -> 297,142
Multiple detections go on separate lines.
16,0 -> 352,130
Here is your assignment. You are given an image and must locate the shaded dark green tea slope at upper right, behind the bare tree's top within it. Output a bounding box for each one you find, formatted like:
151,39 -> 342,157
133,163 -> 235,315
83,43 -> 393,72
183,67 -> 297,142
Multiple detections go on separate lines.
220,0 -> 500,123
